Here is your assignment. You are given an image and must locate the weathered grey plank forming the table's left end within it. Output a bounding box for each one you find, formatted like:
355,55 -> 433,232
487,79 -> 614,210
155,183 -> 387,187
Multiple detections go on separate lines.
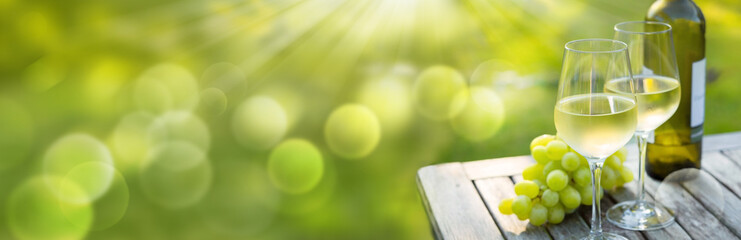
417,163 -> 504,239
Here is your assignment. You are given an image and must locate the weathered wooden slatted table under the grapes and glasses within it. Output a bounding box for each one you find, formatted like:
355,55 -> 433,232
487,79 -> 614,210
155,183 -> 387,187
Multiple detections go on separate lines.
417,132 -> 741,240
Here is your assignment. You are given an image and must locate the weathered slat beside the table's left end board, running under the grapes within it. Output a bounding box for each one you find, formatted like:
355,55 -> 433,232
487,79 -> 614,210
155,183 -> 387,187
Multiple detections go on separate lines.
474,177 -> 550,239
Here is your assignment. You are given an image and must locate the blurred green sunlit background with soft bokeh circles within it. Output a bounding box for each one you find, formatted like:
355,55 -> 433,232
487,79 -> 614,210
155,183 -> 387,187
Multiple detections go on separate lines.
0,0 -> 741,239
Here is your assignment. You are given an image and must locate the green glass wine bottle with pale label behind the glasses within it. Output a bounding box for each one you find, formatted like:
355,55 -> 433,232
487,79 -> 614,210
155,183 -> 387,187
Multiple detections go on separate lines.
646,0 -> 705,180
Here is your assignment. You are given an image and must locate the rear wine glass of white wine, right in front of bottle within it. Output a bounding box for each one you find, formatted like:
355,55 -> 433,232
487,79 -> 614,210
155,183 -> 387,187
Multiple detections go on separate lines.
605,21 -> 681,230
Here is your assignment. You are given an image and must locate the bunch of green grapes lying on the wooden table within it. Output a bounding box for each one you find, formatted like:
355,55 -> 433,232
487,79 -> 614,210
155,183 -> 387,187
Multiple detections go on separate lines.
499,134 -> 633,226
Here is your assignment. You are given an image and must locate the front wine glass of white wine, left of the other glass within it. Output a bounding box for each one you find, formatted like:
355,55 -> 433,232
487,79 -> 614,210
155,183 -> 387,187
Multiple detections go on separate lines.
554,39 -> 638,239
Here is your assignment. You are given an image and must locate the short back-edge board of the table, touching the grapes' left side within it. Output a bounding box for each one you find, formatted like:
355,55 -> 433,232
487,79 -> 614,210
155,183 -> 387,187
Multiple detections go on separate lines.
463,156 -> 535,180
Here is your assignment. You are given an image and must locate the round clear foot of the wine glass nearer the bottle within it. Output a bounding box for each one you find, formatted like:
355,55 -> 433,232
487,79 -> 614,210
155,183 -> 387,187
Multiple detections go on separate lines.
606,200 -> 674,230
